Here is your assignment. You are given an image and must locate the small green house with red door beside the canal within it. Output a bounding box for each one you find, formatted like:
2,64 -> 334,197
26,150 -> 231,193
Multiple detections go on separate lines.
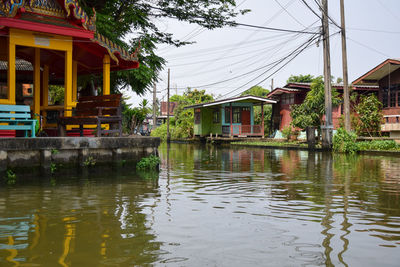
185,95 -> 276,137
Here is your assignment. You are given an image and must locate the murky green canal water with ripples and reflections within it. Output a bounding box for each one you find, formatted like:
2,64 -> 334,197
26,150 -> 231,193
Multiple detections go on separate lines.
0,144 -> 400,266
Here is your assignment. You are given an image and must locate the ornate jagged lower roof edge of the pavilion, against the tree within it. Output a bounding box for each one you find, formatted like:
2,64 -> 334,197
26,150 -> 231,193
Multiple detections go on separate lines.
92,33 -> 140,65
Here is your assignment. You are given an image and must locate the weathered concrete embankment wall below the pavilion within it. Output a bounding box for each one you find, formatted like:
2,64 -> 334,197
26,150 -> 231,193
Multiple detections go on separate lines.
0,136 -> 160,171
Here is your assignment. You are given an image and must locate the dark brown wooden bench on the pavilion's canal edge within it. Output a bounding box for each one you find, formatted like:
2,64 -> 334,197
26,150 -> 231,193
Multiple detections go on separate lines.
57,94 -> 122,137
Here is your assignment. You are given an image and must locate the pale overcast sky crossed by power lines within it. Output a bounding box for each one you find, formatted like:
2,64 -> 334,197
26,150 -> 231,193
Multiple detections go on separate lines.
124,0 -> 400,106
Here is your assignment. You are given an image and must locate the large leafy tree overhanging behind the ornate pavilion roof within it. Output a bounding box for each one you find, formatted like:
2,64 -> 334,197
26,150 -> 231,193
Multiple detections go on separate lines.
80,0 -> 249,94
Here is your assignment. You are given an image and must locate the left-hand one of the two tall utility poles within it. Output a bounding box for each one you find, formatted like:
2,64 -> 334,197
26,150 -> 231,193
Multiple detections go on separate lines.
321,0 -> 333,149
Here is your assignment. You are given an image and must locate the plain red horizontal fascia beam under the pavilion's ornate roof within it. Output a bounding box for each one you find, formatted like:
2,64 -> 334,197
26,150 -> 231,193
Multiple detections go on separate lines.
0,18 -> 94,39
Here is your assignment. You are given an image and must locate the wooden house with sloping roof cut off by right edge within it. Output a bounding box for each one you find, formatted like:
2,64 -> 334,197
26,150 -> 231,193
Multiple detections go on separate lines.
353,59 -> 400,138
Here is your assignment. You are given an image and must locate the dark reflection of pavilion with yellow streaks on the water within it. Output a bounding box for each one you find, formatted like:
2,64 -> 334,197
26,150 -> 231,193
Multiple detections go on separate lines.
0,166 -> 161,266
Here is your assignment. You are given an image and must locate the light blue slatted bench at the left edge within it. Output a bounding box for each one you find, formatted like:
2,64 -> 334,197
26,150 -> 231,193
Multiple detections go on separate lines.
0,105 -> 36,137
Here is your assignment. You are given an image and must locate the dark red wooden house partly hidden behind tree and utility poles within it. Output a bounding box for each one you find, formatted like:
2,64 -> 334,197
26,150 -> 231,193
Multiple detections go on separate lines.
267,83 -> 379,131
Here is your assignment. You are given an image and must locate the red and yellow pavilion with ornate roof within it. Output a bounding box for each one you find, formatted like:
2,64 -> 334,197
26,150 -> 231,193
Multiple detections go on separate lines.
0,0 -> 139,136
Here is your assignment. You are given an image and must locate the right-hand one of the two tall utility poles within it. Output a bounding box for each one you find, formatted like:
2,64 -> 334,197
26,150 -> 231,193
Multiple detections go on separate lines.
340,0 -> 351,132
